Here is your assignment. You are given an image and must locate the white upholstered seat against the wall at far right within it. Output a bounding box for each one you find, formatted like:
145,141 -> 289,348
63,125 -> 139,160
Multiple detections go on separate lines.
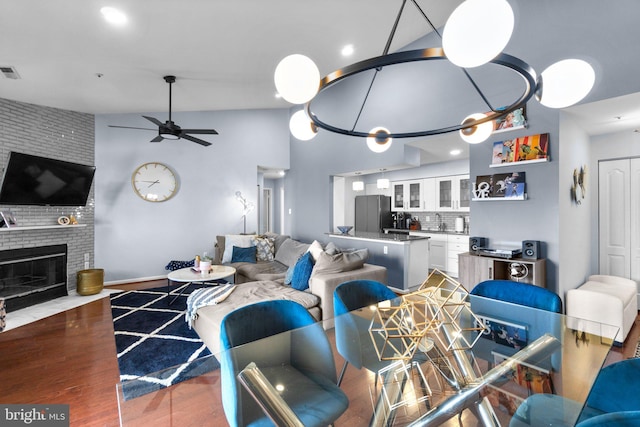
566,275 -> 638,344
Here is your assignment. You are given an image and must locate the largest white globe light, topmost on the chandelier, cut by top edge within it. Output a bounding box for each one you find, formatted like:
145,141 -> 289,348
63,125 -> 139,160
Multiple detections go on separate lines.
442,0 -> 515,68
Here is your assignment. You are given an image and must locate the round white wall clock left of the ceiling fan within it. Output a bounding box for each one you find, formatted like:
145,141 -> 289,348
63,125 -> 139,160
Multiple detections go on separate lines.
131,162 -> 178,202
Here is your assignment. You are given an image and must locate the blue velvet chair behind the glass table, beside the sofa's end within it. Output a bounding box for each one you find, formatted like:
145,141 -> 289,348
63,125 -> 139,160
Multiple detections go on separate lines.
333,280 -> 397,385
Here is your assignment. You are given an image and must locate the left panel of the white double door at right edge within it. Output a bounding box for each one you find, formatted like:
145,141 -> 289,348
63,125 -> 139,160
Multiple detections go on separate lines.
598,159 -> 638,277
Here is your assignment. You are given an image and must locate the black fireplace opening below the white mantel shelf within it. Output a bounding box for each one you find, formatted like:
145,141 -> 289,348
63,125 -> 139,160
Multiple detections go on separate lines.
0,245 -> 67,312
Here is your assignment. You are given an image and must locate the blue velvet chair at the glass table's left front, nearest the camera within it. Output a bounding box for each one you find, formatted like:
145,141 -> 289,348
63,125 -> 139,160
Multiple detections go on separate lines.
220,300 -> 349,427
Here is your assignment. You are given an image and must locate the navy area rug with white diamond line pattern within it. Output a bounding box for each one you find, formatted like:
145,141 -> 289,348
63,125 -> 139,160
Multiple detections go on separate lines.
111,284 -> 219,400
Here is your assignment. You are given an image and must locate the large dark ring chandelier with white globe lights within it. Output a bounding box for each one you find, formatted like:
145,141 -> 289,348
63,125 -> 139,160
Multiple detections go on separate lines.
274,0 -> 595,153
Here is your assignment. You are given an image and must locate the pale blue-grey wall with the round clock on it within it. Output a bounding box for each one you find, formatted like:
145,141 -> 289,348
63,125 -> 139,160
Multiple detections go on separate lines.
95,110 -> 289,282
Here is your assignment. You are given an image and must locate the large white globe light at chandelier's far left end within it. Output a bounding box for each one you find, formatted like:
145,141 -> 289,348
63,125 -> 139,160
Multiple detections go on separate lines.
274,54 -> 320,104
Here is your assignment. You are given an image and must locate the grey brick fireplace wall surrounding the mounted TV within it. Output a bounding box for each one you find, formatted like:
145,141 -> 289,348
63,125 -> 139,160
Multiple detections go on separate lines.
0,99 -> 95,290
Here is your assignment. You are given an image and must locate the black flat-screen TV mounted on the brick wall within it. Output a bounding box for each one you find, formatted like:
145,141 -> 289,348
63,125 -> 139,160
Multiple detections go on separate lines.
0,151 -> 96,206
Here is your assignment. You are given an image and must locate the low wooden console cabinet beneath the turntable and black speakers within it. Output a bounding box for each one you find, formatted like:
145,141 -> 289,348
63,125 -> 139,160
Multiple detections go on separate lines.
458,252 -> 546,291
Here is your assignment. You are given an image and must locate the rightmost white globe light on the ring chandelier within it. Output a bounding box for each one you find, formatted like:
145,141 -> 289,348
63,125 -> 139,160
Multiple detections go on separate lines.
538,59 -> 596,108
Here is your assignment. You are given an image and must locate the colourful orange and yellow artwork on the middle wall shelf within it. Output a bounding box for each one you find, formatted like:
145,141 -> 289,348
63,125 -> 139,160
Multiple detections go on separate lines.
491,133 -> 549,166
